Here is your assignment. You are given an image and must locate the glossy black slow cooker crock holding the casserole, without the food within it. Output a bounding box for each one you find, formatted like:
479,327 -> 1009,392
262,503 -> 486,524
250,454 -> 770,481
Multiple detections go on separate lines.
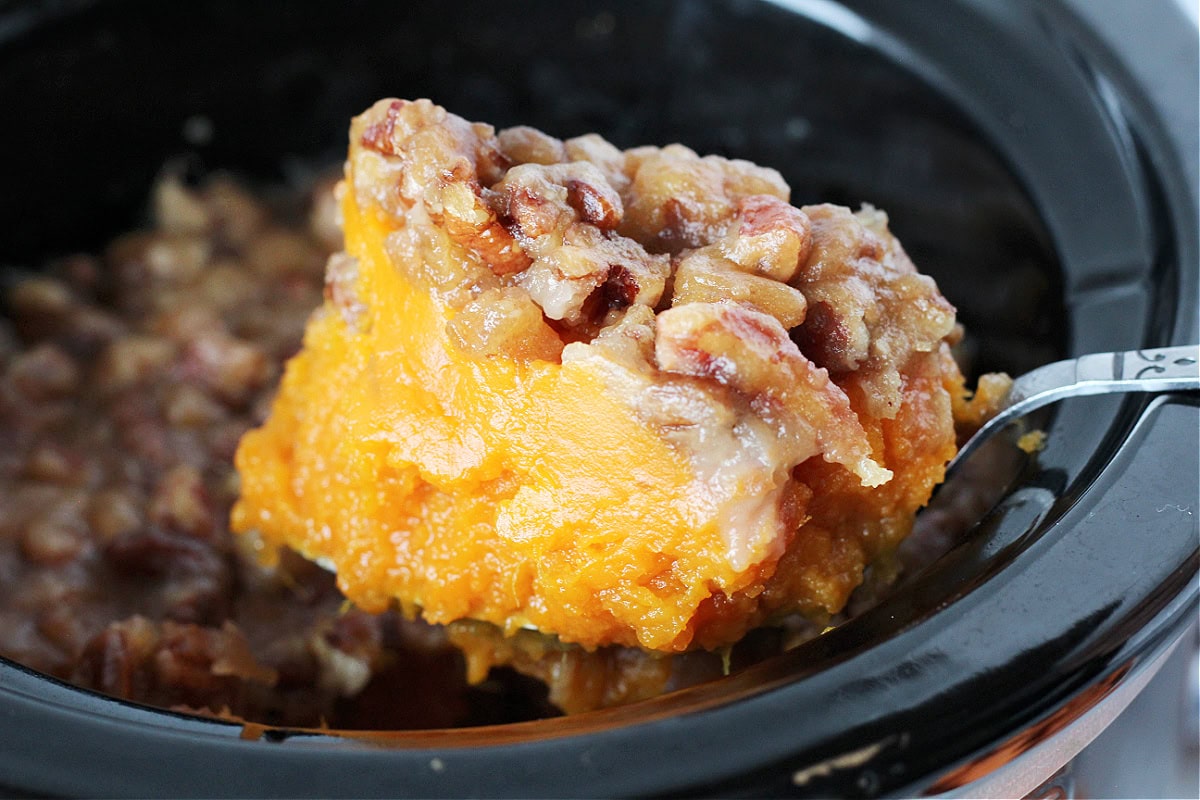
0,0 -> 1200,796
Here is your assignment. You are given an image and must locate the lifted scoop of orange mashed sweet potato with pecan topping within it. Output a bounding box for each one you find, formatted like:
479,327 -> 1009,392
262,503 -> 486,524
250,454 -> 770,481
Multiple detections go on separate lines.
233,100 -> 964,652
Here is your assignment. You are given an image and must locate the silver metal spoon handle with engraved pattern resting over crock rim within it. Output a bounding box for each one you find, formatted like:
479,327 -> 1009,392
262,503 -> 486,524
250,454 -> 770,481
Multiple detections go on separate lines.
946,344 -> 1200,475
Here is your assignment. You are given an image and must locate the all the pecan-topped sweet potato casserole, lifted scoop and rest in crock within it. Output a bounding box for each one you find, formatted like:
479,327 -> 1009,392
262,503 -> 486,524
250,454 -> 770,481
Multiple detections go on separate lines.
0,100 -> 1003,727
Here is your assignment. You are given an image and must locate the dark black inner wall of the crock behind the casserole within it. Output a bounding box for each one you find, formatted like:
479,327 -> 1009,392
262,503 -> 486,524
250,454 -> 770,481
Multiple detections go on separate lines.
0,0 -> 1064,372
